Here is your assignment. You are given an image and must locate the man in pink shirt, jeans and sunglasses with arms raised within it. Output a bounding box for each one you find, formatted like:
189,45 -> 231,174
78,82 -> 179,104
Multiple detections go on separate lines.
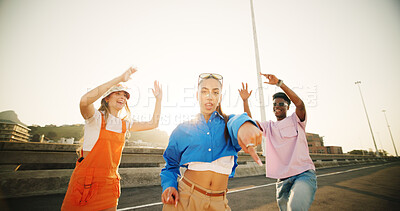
239,74 -> 317,210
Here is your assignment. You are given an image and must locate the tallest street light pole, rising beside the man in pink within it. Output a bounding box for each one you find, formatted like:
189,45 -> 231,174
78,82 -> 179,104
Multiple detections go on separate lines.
250,0 -> 265,122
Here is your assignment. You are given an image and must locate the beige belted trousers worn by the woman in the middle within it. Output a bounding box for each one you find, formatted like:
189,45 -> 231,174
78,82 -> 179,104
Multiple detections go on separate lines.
163,178 -> 231,211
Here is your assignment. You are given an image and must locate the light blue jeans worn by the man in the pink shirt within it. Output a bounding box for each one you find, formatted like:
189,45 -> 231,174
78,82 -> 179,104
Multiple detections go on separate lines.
276,169 -> 317,211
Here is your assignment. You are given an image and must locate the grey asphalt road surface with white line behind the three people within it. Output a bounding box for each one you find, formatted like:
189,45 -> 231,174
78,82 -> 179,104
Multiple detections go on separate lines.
0,162 -> 400,211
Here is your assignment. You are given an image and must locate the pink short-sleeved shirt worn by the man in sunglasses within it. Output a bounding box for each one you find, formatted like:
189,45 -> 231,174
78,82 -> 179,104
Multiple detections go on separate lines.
260,112 -> 315,179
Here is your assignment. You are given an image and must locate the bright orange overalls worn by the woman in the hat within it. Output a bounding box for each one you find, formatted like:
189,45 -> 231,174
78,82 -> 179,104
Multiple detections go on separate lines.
61,114 -> 126,211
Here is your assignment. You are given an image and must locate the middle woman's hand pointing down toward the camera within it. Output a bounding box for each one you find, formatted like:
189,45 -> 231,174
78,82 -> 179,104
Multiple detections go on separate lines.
238,122 -> 262,166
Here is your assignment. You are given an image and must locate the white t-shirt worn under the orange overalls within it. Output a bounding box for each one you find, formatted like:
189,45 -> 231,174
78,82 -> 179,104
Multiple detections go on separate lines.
82,110 -> 131,151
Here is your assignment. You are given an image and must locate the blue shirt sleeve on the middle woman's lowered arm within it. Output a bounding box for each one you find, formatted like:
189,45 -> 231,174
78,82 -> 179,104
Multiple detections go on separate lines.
160,130 -> 182,192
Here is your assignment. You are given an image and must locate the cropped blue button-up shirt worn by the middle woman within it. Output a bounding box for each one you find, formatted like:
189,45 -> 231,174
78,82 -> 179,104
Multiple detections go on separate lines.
160,111 -> 256,192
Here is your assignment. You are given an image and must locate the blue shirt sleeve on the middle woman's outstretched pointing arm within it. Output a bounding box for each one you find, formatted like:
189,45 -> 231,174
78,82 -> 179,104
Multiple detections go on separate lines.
227,113 -> 258,151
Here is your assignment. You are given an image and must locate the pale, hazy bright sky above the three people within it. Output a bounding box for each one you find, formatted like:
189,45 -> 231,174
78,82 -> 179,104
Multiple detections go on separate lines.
0,0 -> 400,155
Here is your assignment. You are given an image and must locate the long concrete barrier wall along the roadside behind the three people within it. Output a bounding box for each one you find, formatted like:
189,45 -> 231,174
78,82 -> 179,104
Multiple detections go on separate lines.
0,142 -> 395,198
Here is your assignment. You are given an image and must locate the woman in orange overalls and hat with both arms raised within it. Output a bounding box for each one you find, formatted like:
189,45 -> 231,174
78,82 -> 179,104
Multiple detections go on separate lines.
61,67 -> 162,211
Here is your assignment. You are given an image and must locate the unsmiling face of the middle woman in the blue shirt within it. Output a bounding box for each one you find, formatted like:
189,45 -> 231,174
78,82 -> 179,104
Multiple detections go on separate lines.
197,78 -> 222,119
